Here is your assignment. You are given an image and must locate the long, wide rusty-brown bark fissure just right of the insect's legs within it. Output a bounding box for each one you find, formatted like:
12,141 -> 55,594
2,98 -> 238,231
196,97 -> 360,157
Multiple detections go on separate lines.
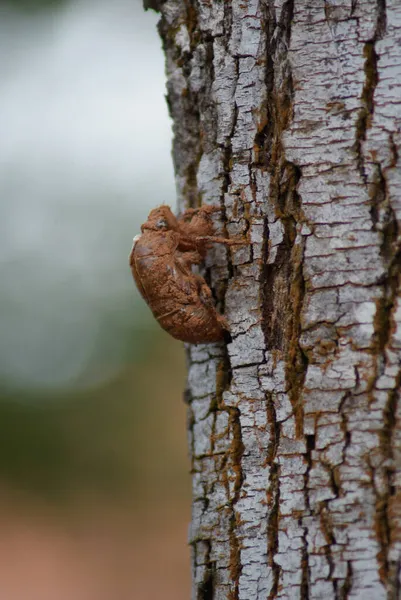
254,0 -> 308,436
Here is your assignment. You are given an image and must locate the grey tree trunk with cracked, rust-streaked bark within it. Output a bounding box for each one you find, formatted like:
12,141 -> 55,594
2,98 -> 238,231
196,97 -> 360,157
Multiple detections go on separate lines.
151,0 -> 401,600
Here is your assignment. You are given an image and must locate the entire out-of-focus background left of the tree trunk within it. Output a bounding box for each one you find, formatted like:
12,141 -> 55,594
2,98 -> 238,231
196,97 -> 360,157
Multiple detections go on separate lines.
0,0 -> 190,600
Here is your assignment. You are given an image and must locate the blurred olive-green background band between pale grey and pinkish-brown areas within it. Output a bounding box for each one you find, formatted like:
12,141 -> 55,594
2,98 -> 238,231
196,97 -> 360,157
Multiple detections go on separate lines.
0,332 -> 188,503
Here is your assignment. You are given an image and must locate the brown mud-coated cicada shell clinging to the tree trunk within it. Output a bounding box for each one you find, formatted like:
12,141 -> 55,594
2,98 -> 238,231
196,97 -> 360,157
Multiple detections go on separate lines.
129,206 -> 235,344
